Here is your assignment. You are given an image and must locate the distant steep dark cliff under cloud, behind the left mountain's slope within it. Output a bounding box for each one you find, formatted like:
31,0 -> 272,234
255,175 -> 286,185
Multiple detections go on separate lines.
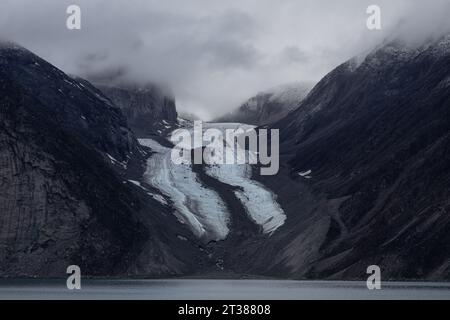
94,84 -> 177,137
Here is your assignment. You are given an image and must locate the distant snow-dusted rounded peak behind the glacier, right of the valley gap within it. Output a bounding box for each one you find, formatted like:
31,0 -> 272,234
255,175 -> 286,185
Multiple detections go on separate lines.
215,83 -> 312,125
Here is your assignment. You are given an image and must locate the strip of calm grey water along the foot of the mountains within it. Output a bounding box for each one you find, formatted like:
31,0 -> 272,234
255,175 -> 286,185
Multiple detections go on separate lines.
0,279 -> 450,300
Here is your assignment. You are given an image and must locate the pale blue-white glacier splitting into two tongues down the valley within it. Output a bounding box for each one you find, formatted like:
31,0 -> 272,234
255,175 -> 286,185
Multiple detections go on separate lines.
139,123 -> 286,241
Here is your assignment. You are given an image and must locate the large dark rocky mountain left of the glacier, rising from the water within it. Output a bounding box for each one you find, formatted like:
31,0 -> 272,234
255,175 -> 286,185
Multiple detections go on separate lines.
0,43 -> 208,277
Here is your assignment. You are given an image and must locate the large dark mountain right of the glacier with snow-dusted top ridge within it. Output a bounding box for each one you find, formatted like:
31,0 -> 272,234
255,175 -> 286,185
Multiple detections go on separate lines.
235,36 -> 450,280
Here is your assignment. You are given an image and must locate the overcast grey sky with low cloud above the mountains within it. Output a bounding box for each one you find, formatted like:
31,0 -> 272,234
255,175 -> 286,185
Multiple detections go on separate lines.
0,0 -> 450,119
